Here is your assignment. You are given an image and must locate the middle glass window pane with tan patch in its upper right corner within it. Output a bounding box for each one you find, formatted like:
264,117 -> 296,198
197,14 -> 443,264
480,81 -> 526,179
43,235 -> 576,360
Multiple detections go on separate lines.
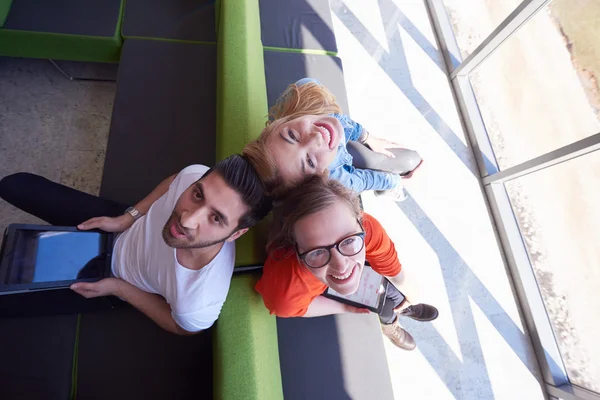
470,0 -> 600,169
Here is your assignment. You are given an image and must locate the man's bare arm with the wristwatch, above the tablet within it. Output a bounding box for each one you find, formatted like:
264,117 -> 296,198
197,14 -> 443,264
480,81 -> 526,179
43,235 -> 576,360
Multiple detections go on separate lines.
77,174 -> 177,232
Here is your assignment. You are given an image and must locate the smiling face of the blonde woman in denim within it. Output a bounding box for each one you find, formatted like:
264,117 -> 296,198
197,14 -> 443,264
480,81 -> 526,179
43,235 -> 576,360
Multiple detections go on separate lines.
267,115 -> 344,182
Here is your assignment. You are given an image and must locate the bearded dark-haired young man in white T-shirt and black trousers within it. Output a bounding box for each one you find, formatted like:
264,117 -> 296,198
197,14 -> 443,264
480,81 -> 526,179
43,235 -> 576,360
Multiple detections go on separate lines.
0,155 -> 271,335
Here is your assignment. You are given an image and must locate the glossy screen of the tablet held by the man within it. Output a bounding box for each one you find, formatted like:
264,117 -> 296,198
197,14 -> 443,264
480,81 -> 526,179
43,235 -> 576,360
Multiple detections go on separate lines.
5,230 -> 106,284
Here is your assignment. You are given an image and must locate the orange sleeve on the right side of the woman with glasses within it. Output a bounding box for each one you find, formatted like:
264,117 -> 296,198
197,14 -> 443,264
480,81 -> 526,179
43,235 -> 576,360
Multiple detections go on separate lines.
363,213 -> 402,276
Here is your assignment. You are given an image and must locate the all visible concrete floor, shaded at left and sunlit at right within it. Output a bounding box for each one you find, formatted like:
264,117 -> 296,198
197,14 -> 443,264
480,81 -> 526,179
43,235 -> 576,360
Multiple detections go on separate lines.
0,0 -> 544,400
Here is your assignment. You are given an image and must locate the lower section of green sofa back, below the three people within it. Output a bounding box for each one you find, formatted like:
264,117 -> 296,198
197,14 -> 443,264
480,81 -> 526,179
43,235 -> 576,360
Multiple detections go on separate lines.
213,274 -> 283,400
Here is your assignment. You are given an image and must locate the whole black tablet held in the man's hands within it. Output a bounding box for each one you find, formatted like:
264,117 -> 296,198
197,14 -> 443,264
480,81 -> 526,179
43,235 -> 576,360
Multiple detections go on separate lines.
0,224 -> 114,294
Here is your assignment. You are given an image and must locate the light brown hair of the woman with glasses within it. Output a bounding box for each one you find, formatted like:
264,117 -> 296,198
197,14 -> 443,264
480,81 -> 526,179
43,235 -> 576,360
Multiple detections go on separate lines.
267,175 -> 362,252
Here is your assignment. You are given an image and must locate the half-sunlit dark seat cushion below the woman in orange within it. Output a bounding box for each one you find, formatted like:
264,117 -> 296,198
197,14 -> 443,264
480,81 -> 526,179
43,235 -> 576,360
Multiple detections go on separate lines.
277,314 -> 394,400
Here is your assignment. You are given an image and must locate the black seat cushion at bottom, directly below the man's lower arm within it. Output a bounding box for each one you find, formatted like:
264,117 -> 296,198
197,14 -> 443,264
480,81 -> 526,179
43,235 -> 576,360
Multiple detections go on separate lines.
77,308 -> 213,400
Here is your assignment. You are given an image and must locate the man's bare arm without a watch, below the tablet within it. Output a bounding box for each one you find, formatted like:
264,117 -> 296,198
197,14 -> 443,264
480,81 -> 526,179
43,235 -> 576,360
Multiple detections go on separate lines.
71,278 -> 200,335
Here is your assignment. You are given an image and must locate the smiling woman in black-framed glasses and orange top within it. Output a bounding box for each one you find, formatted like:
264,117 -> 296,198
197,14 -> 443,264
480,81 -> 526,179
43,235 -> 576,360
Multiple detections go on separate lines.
256,176 -> 438,350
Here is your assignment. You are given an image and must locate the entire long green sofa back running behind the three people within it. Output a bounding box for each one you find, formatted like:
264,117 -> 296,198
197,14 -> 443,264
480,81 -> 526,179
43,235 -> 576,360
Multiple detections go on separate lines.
213,0 -> 283,400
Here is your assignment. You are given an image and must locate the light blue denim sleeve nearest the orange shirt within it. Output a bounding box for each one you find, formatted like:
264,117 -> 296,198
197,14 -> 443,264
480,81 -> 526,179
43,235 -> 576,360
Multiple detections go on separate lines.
329,168 -> 400,193
